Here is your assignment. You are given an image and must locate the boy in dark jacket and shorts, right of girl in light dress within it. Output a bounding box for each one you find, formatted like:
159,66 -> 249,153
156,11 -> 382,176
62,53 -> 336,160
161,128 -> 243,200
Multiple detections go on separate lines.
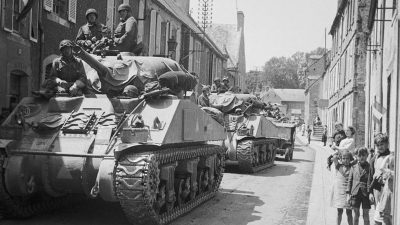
346,147 -> 374,225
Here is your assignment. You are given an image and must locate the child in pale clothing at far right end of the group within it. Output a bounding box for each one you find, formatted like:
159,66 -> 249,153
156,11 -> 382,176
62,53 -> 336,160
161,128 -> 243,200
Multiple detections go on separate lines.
376,155 -> 394,225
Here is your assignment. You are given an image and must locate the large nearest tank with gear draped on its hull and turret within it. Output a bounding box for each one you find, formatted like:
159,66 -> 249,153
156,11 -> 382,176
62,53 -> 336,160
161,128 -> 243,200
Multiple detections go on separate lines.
0,48 -> 225,224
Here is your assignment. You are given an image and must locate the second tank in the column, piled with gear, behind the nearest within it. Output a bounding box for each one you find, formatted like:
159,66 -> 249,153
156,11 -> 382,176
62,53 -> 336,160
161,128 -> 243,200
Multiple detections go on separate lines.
206,92 -> 293,173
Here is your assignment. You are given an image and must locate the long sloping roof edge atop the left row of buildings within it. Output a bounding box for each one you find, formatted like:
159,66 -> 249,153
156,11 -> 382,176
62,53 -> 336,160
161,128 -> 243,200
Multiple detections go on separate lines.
156,0 -> 224,55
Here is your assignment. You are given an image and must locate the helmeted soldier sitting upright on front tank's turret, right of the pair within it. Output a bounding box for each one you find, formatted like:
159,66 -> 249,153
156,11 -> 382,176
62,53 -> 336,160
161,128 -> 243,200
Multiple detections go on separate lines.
114,4 -> 137,52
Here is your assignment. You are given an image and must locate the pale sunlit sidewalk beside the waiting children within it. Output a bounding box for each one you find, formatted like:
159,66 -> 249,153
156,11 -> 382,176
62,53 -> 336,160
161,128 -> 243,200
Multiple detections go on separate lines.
297,133 -> 374,225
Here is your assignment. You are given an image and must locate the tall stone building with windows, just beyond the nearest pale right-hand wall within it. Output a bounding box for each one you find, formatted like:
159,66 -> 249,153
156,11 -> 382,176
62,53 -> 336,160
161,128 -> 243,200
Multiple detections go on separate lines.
324,0 -> 370,145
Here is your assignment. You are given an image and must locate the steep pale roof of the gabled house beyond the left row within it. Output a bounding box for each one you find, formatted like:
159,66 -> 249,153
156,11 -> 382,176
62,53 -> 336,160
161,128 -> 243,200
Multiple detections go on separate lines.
206,24 -> 242,68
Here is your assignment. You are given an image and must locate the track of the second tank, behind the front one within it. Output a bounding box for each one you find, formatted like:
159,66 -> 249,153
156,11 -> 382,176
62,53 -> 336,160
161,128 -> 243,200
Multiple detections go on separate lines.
236,139 -> 276,173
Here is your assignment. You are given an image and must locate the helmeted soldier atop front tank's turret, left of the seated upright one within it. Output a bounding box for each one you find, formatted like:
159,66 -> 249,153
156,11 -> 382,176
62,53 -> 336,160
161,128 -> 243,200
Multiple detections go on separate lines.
75,9 -> 108,50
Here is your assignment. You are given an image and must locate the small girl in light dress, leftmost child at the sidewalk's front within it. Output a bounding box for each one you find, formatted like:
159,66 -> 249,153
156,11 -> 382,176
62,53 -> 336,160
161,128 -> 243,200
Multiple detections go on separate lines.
331,150 -> 353,225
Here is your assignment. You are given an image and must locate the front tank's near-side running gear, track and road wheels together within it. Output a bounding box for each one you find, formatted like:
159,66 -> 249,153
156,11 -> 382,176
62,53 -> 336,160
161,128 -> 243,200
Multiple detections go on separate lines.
114,145 -> 223,225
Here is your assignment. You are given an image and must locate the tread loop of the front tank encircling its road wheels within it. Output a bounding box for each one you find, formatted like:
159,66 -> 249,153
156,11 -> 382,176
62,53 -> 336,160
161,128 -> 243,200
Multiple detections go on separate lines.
114,145 -> 224,225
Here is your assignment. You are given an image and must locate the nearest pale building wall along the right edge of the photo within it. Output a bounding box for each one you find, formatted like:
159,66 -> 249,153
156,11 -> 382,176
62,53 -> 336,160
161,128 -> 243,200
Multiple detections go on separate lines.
365,0 -> 400,224
